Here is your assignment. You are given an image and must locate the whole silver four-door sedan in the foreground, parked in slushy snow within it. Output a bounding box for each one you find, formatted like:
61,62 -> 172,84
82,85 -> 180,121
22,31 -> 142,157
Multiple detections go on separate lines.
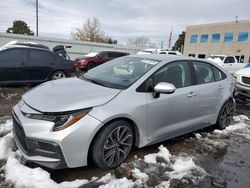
12,55 -> 235,170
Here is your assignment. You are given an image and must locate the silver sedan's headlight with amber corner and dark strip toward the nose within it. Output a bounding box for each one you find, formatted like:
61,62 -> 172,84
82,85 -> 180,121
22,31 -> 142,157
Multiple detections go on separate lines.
23,108 -> 91,131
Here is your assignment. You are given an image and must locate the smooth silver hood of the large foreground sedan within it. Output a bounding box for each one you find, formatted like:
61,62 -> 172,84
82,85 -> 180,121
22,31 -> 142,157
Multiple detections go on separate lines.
22,78 -> 121,112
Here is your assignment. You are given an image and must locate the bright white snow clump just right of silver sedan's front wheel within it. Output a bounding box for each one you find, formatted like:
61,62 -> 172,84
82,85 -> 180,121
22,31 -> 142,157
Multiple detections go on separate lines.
144,145 -> 171,164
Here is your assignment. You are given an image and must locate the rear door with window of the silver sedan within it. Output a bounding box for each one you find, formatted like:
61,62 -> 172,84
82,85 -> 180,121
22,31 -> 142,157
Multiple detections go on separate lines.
192,61 -> 225,125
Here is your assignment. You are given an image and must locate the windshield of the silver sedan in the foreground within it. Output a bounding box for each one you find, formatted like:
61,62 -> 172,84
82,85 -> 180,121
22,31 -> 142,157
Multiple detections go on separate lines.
82,57 -> 159,89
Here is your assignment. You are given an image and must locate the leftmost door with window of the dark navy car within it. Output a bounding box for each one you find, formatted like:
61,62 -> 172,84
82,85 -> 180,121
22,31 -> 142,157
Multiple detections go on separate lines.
0,48 -> 28,83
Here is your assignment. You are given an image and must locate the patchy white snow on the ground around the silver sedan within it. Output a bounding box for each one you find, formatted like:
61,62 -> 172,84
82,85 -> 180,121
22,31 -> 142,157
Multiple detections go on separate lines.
0,115 -> 250,188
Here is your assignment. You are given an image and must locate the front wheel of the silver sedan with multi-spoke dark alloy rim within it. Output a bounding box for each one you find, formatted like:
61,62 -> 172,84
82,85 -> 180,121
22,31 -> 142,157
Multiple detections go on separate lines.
92,120 -> 134,170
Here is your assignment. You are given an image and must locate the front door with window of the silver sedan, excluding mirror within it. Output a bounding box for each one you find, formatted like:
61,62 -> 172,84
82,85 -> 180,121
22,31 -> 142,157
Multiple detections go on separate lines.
147,61 -> 196,141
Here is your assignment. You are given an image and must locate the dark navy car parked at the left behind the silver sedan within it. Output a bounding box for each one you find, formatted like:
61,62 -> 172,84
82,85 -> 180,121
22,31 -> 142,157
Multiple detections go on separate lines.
0,43 -> 73,84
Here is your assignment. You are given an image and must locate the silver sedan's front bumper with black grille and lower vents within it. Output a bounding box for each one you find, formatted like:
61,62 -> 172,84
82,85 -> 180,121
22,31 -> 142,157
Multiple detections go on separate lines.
12,105 -> 102,169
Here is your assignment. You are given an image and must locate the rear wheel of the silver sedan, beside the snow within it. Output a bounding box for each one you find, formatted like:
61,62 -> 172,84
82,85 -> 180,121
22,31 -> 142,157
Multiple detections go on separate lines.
216,100 -> 234,130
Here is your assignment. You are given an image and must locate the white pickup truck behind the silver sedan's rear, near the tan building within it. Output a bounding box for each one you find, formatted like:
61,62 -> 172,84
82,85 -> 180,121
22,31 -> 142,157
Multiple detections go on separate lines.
207,55 -> 246,74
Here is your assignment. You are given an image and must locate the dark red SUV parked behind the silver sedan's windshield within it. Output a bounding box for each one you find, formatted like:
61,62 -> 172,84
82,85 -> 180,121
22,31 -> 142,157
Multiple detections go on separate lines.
76,51 -> 129,71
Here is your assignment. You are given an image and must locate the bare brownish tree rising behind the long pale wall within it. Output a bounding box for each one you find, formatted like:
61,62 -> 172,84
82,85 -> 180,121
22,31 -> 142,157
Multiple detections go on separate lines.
71,17 -> 117,44
